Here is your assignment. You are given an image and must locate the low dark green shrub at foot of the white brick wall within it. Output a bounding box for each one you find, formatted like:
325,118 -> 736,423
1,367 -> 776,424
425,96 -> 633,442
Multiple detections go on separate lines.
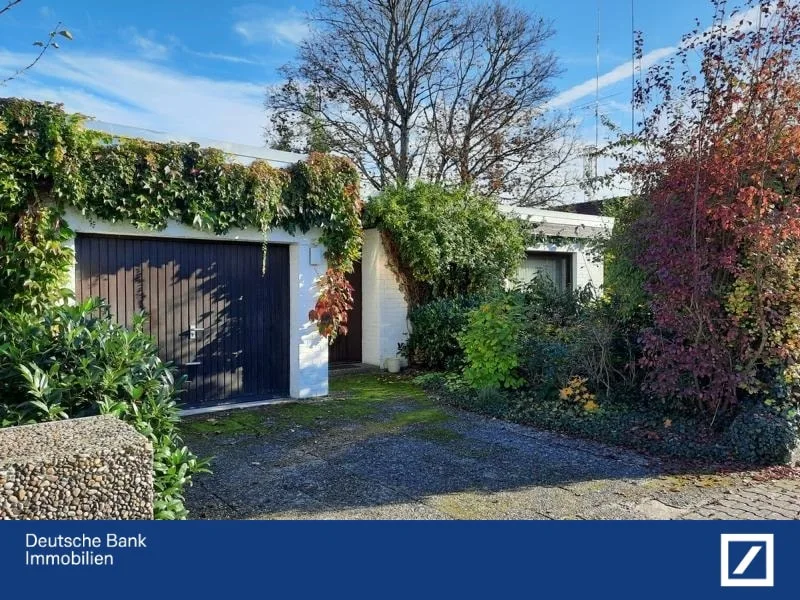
400,296 -> 480,370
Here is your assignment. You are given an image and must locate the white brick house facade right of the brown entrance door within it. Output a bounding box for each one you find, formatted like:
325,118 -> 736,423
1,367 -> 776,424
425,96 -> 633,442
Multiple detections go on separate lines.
362,211 -> 614,369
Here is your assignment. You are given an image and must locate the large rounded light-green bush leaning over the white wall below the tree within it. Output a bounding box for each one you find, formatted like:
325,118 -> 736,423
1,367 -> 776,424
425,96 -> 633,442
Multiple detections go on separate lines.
364,182 -> 525,304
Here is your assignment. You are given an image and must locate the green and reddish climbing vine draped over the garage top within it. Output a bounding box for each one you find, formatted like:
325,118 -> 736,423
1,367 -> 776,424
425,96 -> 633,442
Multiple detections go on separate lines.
0,98 -> 361,338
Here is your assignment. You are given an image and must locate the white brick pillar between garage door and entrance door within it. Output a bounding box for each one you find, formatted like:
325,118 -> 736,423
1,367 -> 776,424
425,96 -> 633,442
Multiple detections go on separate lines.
289,244 -> 328,398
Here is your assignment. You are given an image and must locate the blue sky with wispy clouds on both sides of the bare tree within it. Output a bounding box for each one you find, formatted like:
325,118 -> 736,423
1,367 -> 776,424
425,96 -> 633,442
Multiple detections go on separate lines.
0,0 -> 724,145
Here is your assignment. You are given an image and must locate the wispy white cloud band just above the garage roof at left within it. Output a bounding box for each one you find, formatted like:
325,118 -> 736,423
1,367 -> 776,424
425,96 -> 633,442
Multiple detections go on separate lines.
0,51 -> 266,146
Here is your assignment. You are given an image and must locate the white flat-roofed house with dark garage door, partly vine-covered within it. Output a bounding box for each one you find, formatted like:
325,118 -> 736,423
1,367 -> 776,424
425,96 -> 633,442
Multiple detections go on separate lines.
73,121 -> 613,409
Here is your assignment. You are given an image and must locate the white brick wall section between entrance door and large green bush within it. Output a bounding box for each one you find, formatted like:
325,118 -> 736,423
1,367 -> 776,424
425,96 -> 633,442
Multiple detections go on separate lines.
361,229 -> 408,368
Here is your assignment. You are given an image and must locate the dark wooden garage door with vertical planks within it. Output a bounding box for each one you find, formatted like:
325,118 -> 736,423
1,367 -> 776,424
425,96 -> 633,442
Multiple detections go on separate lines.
75,235 -> 289,406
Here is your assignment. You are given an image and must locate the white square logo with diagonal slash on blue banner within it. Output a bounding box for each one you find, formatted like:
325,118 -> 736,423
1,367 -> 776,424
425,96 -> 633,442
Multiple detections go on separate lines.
720,533 -> 775,587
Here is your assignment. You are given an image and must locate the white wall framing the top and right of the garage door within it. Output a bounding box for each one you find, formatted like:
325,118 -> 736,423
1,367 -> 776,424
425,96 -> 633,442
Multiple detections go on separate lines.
65,209 -> 328,398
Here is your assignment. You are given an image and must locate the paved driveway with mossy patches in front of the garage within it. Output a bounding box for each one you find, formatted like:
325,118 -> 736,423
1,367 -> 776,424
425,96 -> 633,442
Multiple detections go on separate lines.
186,376 -> 800,519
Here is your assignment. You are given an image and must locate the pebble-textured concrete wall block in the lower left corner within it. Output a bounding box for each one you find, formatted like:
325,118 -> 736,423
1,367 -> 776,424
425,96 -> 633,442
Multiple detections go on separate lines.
0,416 -> 153,519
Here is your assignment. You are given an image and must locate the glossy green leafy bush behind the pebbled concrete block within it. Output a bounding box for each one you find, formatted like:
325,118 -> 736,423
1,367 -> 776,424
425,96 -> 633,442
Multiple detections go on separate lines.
0,300 -> 206,519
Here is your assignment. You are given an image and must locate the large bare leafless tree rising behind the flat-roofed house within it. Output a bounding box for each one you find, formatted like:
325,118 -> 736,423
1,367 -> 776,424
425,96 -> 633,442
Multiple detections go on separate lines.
266,0 -> 571,203
